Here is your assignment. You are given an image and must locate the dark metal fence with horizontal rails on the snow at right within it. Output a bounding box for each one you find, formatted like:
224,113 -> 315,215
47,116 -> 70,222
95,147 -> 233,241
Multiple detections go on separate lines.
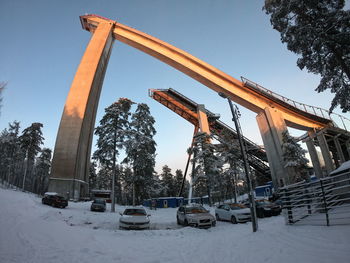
279,172 -> 350,226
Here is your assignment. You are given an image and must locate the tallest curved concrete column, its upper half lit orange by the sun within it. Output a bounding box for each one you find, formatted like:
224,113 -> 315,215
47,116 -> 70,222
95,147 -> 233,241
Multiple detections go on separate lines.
49,22 -> 114,199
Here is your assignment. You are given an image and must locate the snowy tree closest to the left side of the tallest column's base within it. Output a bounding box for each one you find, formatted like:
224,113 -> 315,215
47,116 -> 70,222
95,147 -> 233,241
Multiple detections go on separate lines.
33,148 -> 52,195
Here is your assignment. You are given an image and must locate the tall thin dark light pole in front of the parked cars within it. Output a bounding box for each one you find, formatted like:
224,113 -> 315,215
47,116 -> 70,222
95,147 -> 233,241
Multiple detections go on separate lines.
219,92 -> 258,232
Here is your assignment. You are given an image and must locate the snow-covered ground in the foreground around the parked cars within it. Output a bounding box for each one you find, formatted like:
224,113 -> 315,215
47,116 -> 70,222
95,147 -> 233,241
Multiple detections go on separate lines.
0,188 -> 350,263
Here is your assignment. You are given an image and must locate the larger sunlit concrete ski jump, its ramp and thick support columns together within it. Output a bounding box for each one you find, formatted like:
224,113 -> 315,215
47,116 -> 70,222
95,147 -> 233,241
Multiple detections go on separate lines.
49,15 -> 350,199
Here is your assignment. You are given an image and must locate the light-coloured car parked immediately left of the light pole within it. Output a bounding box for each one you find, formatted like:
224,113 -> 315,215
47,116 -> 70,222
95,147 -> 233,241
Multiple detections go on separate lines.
215,203 -> 251,224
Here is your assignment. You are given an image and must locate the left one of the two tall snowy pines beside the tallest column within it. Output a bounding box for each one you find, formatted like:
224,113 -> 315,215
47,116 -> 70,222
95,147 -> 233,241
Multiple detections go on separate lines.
93,98 -> 133,208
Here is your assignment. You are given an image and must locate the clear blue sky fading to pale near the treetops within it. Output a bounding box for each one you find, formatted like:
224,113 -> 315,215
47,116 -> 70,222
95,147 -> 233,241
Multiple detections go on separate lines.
0,0 -> 350,170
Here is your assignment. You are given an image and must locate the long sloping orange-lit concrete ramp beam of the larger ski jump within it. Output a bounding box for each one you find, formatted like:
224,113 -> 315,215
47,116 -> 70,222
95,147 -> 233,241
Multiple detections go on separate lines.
80,15 -> 330,130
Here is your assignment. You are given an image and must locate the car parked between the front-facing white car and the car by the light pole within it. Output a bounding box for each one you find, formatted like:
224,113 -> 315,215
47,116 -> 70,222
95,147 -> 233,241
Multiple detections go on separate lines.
176,205 -> 216,228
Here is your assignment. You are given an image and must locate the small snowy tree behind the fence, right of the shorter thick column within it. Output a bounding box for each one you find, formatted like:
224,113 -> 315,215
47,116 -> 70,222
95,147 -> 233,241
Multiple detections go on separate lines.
282,131 -> 308,183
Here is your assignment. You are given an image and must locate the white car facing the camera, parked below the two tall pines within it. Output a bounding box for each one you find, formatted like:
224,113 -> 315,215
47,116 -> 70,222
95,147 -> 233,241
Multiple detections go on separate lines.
119,207 -> 150,229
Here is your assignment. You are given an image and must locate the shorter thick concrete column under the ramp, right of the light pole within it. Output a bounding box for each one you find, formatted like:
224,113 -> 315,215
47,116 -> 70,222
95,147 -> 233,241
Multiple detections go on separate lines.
256,108 -> 290,189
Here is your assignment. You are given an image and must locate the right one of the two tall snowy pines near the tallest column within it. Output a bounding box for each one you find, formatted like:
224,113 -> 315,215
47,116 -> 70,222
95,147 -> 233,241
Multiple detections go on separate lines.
124,103 -> 156,206
